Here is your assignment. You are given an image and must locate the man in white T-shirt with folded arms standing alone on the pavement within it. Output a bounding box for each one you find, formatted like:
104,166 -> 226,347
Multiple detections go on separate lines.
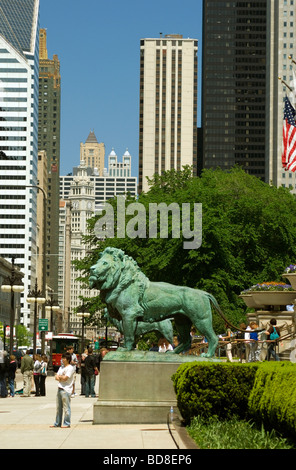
51,352 -> 74,428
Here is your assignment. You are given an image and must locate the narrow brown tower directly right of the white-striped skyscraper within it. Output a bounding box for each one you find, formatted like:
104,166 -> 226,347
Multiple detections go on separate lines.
38,29 -> 61,292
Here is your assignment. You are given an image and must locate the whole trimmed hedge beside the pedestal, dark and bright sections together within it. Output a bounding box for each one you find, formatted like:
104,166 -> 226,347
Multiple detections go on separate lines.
172,362 -> 296,437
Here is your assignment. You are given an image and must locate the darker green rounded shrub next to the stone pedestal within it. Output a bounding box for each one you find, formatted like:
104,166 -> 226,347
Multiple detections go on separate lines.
172,362 -> 258,424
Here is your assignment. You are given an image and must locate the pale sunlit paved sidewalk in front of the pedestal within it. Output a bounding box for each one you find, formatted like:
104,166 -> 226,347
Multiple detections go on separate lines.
0,371 -> 194,450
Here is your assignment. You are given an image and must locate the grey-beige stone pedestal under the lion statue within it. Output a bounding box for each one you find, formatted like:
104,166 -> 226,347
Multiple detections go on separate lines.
93,361 -> 180,424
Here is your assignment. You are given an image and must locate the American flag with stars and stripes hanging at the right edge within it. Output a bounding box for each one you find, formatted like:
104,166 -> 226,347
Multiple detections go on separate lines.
282,96 -> 296,172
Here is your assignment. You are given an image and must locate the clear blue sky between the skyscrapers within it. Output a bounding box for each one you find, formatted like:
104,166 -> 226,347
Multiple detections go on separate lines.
40,0 -> 202,176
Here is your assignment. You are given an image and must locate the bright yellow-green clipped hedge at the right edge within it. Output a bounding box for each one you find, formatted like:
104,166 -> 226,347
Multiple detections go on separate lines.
249,362 -> 296,438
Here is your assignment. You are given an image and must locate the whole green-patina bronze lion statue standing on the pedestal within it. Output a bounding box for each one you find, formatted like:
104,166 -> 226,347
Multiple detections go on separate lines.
89,247 -> 220,357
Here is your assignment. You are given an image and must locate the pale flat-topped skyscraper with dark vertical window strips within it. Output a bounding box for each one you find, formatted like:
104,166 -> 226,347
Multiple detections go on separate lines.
139,34 -> 197,192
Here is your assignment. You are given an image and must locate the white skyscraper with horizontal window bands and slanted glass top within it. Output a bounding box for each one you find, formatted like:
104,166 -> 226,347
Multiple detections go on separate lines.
0,0 -> 41,326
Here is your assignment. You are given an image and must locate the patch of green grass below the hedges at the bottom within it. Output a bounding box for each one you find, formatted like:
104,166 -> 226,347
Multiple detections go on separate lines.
187,417 -> 295,449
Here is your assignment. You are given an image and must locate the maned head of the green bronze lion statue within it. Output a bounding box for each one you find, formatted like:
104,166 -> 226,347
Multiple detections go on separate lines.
89,247 -> 149,291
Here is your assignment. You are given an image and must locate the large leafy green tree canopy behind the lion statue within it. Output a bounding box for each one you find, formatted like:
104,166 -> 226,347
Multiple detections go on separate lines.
75,167 -> 296,333
